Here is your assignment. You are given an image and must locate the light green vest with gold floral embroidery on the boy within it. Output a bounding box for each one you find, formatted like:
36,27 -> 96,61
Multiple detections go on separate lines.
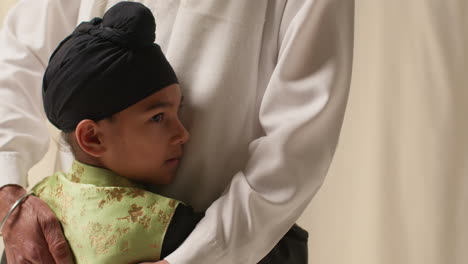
33,161 -> 180,264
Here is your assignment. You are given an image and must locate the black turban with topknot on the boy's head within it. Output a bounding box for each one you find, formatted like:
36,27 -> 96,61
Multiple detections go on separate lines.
42,2 -> 178,132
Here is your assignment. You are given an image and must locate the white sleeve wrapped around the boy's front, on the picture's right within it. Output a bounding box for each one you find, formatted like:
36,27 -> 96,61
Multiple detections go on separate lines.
166,0 -> 354,264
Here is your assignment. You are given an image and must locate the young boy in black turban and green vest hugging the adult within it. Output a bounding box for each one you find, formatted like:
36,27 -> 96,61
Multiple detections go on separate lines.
11,2 -> 307,263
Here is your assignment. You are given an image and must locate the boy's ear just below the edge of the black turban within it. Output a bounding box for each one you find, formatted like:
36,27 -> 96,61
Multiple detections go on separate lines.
75,119 -> 106,157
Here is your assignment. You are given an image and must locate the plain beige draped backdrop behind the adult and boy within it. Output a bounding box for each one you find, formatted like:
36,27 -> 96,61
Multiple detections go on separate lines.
0,0 -> 468,264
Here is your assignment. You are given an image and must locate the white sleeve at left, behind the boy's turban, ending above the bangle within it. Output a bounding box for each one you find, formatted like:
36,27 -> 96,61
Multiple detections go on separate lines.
0,0 -> 80,186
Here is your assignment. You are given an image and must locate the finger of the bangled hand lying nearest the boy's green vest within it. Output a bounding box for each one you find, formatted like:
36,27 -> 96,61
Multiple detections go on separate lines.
41,209 -> 73,264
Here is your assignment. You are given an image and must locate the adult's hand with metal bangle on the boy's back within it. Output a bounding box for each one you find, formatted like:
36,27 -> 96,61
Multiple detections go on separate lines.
0,185 -> 73,264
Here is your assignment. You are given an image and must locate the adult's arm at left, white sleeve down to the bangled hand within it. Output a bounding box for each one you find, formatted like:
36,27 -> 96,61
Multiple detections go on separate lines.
0,0 -> 80,263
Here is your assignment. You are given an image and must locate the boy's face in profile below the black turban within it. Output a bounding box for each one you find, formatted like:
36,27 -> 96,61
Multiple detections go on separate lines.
99,84 -> 189,184
